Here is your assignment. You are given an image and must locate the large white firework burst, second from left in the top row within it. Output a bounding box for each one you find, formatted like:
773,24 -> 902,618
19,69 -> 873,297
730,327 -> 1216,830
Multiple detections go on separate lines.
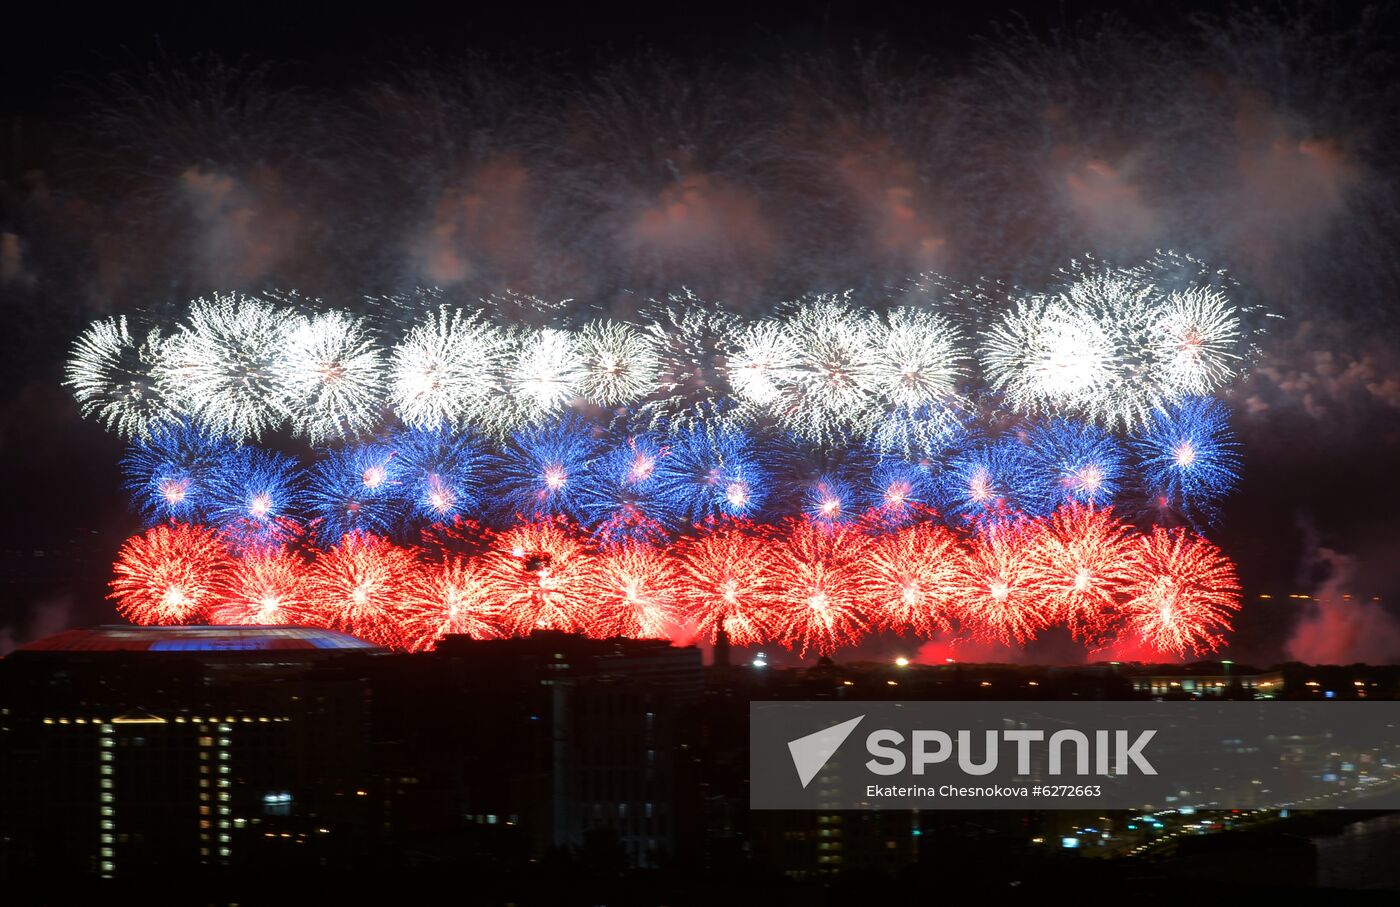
153,293 -> 301,441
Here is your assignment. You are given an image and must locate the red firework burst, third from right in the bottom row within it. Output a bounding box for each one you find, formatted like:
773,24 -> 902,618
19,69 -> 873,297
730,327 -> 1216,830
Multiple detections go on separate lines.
952,525 -> 1050,645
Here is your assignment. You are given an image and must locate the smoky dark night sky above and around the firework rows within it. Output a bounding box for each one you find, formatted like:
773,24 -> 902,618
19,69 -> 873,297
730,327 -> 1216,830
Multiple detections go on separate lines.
0,3 -> 1400,663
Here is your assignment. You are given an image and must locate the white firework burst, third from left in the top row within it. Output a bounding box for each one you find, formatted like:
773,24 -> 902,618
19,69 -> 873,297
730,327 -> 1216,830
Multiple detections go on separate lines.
277,312 -> 384,444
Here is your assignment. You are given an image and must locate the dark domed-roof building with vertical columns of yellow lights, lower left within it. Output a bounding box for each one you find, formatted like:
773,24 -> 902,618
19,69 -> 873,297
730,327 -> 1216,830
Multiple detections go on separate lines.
0,627 -> 377,878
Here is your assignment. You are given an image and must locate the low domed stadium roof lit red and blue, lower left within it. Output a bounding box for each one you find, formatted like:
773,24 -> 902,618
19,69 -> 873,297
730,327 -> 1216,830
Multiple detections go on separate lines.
20,626 -> 379,652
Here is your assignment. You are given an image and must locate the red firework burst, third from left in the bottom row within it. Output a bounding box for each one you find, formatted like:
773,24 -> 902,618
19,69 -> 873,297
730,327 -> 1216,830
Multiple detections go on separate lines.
307,535 -> 416,647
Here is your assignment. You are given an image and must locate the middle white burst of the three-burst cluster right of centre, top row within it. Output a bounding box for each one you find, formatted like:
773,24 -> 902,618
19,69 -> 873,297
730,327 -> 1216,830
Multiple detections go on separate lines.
776,297 -> 879,444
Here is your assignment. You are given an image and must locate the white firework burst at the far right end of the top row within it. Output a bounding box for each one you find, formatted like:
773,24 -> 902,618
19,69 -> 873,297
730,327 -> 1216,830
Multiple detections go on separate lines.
1147,287 -> 1240,398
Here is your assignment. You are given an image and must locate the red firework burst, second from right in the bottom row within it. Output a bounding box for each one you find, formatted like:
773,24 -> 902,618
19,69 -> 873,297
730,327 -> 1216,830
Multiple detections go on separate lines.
1030,505 -> 1134,644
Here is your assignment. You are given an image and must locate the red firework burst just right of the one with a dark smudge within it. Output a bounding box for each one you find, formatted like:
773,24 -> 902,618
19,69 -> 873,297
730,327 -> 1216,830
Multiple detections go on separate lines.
585,544 -> 680,640
